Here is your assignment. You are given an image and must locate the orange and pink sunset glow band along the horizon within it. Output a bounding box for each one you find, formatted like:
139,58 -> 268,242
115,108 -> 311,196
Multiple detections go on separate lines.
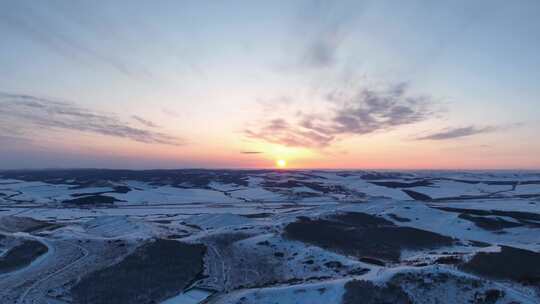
36,132 -> 540,170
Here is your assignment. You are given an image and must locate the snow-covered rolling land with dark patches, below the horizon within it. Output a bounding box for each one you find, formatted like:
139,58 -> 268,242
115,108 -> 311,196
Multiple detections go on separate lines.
0,170 -> 540,304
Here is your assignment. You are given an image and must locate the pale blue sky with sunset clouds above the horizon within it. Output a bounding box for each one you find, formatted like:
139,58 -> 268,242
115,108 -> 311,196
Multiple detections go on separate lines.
0,0 -> 540,169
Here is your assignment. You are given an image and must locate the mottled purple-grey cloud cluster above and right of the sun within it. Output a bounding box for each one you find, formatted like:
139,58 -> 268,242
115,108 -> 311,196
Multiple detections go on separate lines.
245,84 -> 433,147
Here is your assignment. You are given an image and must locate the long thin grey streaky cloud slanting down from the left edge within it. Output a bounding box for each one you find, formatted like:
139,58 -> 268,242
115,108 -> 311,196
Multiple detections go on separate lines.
0,92 -> 183,145
